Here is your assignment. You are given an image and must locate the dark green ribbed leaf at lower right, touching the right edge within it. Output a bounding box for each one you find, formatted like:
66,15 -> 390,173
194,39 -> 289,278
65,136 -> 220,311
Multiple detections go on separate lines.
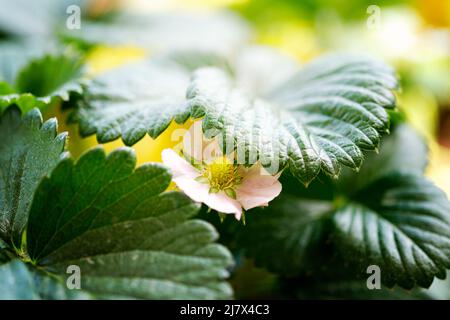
333,173 -> 450,288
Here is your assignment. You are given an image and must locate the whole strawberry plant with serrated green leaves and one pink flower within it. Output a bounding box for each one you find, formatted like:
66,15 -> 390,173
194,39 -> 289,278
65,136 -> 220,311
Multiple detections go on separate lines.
0,0 -> 450,299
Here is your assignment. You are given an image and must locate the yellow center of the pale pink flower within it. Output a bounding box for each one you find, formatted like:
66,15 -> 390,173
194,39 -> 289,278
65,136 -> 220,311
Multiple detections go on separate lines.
203,156 -> 242,192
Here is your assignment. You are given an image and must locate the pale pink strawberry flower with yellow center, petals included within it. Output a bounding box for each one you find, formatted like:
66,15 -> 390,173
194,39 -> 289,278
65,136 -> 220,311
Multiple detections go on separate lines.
162,122 -> 281,220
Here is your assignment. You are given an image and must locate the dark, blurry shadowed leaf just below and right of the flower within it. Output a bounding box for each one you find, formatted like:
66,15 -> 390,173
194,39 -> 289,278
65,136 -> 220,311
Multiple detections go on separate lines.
239,194 -> 332,276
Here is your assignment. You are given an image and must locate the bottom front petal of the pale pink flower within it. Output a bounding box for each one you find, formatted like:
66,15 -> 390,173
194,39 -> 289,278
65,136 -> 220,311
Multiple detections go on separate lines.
173,176 -> 242,220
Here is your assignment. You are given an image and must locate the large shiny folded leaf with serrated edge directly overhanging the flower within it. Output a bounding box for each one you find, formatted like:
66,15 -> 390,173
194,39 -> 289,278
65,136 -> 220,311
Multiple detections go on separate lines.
187,51 -> 396,185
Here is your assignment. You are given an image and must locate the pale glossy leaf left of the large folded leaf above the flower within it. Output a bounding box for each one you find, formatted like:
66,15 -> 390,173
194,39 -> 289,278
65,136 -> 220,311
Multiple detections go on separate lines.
70,62 -> 189,145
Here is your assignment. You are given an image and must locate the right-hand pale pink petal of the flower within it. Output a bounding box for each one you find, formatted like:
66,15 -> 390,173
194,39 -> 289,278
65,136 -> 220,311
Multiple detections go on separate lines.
236,164 -> 281,210
